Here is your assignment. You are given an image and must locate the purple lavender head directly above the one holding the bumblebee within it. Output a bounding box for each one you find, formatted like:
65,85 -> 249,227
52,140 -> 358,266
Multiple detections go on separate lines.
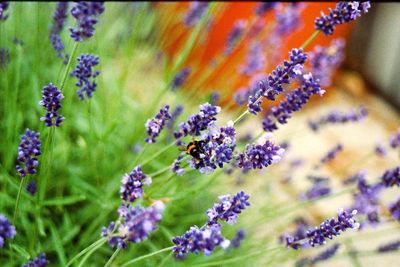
174,103 -> 221,139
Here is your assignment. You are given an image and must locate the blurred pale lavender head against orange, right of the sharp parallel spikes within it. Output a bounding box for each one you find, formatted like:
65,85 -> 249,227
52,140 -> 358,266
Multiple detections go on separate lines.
310,39 -> 346,86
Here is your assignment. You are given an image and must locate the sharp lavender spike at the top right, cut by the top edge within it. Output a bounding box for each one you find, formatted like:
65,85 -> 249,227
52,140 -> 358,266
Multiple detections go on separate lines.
315,1 -> 371,35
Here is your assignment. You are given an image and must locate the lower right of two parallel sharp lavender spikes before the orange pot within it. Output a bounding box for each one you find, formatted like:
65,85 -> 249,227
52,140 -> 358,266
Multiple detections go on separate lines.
262,73 -> 325,132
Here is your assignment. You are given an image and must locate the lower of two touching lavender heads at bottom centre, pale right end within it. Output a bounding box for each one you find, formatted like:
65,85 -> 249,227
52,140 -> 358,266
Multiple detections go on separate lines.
172,224 -> 230,259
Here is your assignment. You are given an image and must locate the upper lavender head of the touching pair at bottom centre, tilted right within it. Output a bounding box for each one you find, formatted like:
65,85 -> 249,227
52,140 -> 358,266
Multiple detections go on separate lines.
207,191 -> 250,225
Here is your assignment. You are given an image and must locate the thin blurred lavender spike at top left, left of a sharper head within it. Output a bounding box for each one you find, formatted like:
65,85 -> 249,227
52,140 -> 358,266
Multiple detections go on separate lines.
50,2 -> 68,63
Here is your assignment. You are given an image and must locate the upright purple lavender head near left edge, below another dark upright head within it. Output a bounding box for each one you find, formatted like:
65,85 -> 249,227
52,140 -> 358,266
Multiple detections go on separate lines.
16,129 -> 41,177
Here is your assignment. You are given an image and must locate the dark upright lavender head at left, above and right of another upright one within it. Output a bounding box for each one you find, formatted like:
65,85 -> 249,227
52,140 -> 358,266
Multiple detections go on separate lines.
39,83 -> 64,127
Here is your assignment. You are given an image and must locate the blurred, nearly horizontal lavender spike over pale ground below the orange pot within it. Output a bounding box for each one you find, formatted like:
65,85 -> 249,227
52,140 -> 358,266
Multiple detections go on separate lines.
308,106 -> 368,132
